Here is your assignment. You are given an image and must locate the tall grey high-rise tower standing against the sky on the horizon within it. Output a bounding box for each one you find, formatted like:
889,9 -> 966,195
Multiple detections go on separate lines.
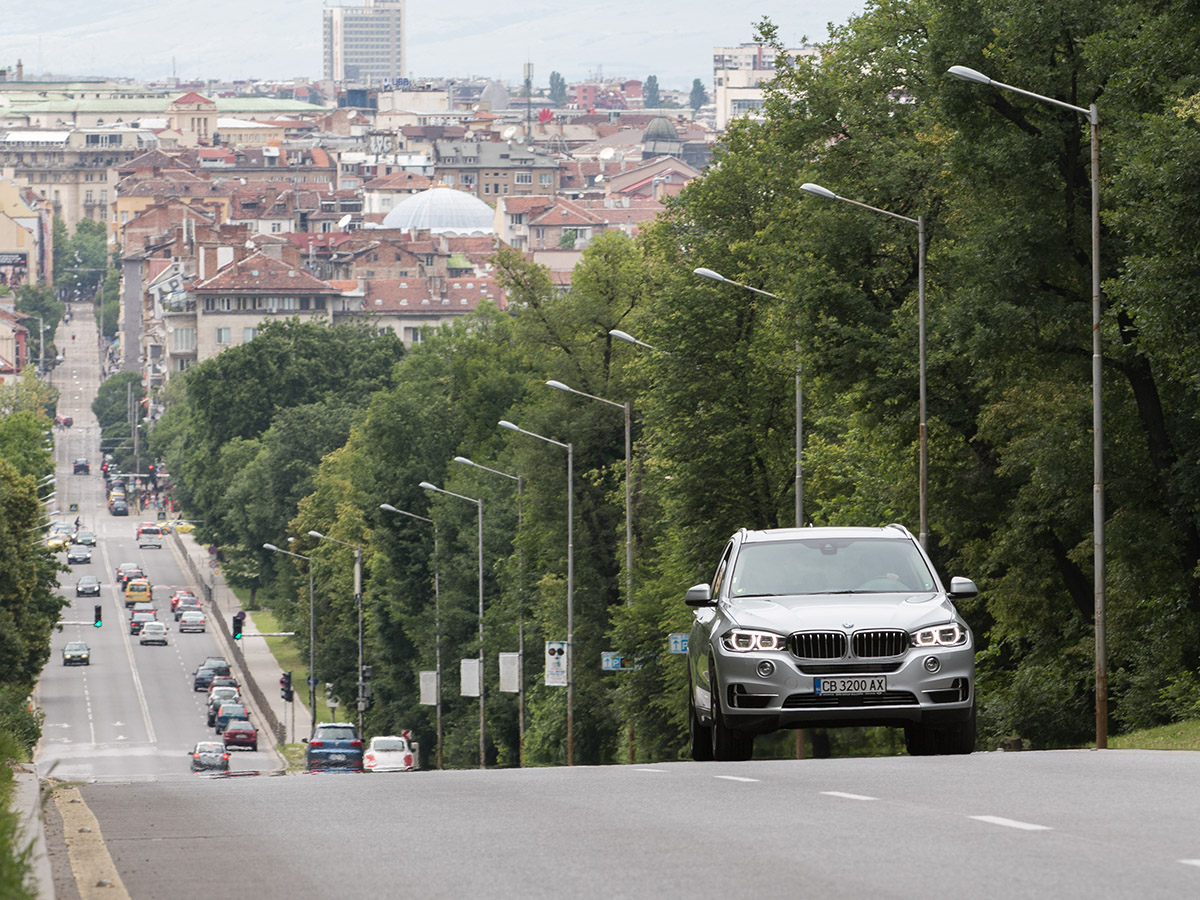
322,0 -> 407,85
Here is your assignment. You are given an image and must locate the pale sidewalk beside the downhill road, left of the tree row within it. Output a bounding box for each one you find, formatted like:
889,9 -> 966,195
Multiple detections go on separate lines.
170,532 -> 312,744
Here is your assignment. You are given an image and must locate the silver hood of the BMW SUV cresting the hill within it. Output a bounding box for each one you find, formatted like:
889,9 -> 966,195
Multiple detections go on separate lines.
726,593 -> 961,634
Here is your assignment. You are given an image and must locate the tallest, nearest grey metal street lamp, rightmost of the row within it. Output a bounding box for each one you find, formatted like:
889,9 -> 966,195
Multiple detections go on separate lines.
948,66 -> 1109,750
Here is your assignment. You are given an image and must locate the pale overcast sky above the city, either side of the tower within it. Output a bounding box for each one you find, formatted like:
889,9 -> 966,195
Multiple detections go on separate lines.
0,0 -> 868,90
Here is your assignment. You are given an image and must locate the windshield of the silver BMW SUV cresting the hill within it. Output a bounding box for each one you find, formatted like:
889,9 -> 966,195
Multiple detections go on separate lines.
730,538 -> 934,596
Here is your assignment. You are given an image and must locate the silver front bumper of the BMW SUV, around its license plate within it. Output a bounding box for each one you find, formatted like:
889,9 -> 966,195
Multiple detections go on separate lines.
697,643 -> 974,733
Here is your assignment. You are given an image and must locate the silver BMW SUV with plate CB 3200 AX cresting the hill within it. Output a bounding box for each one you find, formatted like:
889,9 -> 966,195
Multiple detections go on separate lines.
685,524 -> 978,760
